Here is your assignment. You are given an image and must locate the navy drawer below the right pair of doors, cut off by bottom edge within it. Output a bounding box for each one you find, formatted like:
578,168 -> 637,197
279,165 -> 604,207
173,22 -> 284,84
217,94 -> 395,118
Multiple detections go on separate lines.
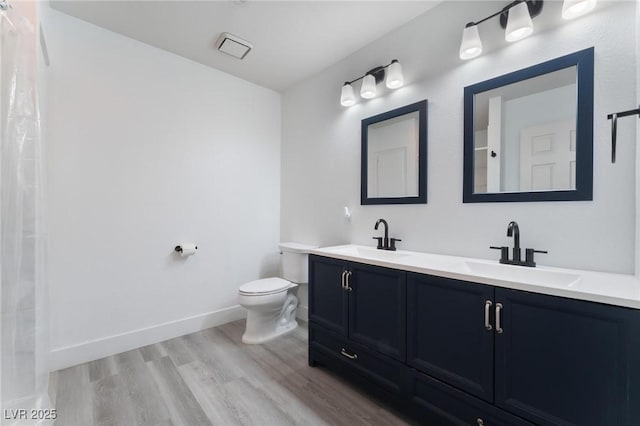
409,369 -> 533,426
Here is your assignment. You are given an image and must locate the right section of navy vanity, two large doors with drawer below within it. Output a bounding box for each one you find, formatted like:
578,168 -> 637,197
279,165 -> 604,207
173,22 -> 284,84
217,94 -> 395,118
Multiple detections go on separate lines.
407,273 -> 640,426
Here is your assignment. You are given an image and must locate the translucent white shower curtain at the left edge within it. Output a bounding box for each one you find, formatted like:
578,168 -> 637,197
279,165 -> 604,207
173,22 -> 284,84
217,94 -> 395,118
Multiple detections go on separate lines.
0,5 -> 50,425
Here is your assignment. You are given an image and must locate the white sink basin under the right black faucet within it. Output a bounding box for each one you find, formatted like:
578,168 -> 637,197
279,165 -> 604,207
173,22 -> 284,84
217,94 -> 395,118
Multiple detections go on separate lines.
451,261 -> 580,287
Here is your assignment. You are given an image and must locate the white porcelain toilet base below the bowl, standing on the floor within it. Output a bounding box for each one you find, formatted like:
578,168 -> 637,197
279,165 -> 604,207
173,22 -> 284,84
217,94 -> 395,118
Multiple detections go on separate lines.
242,293 -> 298,344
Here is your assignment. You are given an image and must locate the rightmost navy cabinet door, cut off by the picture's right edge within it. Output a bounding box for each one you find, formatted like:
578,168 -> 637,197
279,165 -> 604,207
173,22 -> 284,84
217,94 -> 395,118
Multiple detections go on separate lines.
495,289 -> 640,426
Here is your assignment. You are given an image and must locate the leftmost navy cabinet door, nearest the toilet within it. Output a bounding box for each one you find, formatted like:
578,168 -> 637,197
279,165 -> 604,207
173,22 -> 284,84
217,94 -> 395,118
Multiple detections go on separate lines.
309,255 -> 348,336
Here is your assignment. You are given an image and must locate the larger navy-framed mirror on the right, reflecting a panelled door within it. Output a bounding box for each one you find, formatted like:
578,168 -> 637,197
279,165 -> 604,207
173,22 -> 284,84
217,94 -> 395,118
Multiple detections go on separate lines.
463,48 -> 594,203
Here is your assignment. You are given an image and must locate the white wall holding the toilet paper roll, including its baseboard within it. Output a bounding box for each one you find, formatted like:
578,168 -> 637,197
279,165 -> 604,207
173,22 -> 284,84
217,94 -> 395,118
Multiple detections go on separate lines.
43,8 -> 281,369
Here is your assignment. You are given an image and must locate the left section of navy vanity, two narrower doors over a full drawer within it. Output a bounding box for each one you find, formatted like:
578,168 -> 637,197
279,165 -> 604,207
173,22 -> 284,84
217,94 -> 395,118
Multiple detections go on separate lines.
309,255 -> 406,394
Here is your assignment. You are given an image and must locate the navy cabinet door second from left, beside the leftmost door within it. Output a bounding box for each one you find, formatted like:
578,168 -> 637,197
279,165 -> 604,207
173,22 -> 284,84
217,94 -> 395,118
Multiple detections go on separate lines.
348,263 -> 406,362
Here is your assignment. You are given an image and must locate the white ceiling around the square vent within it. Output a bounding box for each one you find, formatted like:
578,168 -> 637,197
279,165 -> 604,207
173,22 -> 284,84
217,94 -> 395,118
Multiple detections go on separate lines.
51,0 -> 442,91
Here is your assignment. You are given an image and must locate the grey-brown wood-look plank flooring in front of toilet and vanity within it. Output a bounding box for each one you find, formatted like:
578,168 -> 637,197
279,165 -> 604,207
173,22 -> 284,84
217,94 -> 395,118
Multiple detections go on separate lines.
49,320 -> 407,426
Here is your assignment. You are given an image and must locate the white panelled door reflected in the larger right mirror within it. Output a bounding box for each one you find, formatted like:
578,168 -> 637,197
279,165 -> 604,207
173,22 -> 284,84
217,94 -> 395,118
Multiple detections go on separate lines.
520,120 -> 576,191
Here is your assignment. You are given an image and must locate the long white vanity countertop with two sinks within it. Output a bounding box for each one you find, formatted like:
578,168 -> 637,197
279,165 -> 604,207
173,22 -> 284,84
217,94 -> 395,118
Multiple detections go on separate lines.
309,244 -> 640,309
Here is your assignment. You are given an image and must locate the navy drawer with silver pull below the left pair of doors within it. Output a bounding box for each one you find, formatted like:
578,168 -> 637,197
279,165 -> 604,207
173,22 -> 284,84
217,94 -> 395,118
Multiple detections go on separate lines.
309,323 -> 406,394
